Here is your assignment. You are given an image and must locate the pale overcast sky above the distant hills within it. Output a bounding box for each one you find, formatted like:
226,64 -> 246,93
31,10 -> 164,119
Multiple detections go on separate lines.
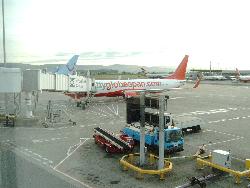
0,0 -> 250,69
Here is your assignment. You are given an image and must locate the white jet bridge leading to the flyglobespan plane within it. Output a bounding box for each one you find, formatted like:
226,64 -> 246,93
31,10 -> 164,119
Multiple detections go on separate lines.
0,67 -> 94,118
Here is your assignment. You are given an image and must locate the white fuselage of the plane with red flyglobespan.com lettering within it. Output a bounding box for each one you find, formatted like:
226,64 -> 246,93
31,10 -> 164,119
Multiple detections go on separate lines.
95,79 -> 186,93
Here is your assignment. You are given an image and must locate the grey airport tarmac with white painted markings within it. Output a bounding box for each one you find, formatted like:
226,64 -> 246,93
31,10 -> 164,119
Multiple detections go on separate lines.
0,82 -> 250,188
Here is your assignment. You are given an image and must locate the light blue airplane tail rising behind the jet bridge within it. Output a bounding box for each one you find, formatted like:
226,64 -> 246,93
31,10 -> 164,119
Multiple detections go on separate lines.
53,55 -> 79,75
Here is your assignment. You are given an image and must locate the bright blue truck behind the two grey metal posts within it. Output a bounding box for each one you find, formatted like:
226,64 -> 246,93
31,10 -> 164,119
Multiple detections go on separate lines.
122,124 -> 184,153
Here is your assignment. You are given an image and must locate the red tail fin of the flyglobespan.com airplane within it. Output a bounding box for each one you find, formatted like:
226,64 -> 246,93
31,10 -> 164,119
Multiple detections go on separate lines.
165,55 -> 188,80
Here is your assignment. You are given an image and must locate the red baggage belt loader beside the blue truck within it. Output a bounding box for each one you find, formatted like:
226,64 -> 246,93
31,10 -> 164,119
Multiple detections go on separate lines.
93,127 -> 134,153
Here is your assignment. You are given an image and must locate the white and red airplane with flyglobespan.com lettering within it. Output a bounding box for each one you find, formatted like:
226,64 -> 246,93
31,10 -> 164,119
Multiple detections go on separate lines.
65,55 -> 200,100
